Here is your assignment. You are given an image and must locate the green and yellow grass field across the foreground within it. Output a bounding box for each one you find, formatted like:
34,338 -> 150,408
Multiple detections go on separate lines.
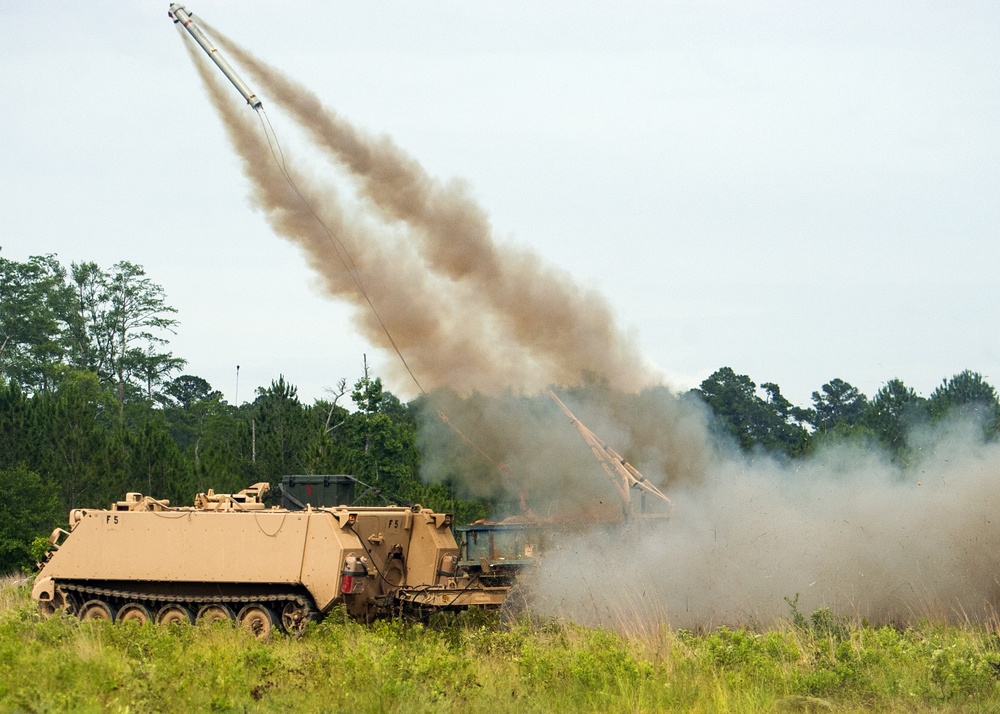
0,583 -> 1000,713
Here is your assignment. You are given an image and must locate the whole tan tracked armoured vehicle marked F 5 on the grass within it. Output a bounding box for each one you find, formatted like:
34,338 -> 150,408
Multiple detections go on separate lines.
31,483 -> 507,636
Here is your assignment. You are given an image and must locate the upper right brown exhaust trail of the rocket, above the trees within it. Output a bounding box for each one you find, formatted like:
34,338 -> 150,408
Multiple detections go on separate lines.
210,28 -> 661,390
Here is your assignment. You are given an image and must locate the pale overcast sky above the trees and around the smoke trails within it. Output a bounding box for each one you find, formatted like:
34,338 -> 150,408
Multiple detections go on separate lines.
0,0 -> 1000,405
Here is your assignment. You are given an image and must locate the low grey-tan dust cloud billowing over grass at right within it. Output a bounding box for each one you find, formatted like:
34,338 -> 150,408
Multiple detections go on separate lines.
533,412 -> 1000,629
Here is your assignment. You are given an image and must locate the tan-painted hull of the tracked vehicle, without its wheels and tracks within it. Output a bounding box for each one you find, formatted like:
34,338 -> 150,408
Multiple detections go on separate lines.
32,484 -> 506,616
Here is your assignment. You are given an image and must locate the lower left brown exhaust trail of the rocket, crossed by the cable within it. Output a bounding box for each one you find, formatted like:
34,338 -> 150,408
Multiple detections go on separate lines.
177,32 -> 552,391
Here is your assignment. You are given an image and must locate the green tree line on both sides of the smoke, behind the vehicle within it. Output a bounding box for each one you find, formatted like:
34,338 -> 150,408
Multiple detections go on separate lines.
0,255 -> 998,573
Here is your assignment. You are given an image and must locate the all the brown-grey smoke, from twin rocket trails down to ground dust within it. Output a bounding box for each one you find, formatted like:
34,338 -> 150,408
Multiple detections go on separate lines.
185,25 -> 1000,627
